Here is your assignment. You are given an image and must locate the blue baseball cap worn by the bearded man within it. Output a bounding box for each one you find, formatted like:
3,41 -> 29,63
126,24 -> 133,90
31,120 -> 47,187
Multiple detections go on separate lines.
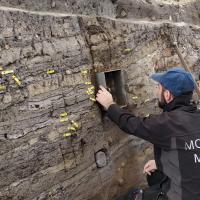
151,67 -> 195,96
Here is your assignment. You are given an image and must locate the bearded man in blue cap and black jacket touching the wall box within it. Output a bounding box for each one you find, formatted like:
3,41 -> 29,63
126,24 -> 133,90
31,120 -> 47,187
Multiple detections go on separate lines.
96,67 -> 200,200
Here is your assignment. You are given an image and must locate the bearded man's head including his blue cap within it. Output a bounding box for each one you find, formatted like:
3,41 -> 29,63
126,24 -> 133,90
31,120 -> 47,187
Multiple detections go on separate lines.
151,67 -> 195,108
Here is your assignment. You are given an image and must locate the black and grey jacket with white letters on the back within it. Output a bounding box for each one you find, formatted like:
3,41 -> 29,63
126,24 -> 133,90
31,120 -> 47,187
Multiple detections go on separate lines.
107,98 -> 200,200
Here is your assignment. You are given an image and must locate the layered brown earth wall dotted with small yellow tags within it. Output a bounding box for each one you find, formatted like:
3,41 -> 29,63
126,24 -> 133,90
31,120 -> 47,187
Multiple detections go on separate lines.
0,0 -> 200,200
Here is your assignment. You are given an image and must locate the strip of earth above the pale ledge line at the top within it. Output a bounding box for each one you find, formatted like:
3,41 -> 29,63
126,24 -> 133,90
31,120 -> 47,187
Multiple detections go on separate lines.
0,0 -> 200,24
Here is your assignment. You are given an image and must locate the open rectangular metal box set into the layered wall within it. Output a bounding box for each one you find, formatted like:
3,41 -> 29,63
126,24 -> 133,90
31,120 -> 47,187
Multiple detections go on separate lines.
96,70 -> 127,107
